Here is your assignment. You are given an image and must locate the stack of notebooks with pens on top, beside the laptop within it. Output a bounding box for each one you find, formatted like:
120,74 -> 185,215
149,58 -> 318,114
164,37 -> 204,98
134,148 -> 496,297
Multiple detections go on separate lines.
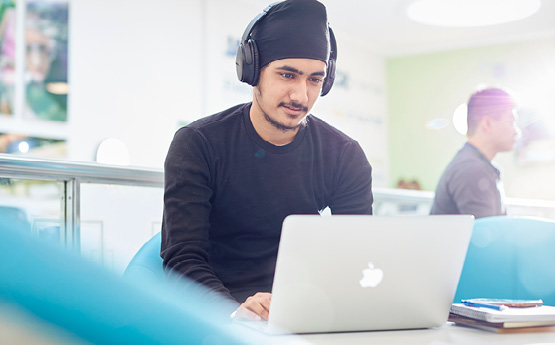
449,303 -> 555,333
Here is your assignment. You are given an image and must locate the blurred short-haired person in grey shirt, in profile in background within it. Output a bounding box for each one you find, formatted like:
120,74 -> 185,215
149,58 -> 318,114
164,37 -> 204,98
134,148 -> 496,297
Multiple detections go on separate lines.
430,88 -> 520,218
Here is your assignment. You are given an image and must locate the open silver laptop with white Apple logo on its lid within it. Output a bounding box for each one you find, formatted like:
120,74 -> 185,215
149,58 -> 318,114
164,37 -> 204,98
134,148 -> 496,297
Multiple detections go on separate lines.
256,215 -> 474,333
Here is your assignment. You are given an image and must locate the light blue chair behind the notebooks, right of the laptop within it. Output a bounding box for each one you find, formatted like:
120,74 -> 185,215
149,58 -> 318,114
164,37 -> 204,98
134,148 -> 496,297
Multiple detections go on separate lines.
454,216 -> 555,305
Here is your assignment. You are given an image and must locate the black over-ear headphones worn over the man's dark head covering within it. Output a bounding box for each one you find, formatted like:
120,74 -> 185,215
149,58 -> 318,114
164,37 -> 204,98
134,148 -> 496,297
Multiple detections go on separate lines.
235,1 -> 337,96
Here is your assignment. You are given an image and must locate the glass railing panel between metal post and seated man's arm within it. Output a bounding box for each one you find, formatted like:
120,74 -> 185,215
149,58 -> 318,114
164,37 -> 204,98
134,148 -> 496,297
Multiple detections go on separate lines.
79,183 -> 163,274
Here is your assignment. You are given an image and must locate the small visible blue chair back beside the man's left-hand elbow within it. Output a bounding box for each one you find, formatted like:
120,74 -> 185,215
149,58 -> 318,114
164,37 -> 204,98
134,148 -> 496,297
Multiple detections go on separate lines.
123,232 -> 165,282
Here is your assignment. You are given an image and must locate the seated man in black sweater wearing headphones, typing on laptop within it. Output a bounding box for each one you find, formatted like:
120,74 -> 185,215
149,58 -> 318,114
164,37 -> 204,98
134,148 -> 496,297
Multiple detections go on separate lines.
161,0 -> 373,320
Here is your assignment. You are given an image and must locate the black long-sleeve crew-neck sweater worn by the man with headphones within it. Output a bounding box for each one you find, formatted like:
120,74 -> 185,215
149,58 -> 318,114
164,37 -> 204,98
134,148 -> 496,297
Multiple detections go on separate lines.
161,103 -> 373,310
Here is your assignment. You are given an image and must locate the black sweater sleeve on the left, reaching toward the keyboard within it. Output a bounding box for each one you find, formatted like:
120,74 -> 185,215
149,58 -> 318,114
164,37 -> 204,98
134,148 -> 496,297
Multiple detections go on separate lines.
160,127 -> 239,306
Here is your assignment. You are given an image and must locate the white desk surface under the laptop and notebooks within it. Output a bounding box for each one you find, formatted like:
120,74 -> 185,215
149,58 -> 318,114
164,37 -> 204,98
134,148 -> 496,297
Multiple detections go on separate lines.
276,323 -> 555,345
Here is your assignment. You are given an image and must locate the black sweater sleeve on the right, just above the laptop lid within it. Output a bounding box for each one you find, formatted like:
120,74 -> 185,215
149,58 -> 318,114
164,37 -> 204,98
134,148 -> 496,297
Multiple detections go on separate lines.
330,141 -> 373,214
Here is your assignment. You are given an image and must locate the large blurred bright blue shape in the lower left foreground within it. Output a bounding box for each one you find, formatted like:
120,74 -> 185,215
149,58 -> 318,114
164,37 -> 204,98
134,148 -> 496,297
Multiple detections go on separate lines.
0,222 -> 301,345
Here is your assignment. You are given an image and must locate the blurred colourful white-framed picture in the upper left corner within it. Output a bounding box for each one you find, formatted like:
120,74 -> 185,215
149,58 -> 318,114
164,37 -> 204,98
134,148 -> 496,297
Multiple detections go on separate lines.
0,0 -> 69,122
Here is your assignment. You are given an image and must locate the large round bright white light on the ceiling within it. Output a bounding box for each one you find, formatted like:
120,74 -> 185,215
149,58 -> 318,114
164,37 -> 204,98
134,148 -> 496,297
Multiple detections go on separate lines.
407,0 -> 541,27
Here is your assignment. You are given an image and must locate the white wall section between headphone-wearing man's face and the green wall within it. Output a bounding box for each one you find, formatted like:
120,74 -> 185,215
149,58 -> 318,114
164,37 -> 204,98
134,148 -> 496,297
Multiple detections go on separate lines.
313,34 -> 389,187
